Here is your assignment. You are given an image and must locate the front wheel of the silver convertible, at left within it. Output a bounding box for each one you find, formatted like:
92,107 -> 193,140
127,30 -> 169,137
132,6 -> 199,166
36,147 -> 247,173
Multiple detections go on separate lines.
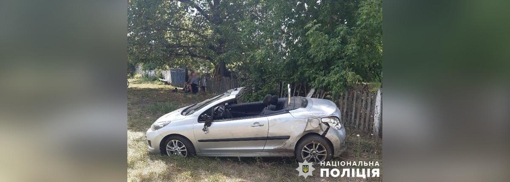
163,136 -> 196,157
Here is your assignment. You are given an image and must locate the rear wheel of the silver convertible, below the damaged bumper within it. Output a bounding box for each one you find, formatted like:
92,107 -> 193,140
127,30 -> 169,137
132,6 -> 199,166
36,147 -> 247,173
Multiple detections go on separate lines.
295,135 -> 333,163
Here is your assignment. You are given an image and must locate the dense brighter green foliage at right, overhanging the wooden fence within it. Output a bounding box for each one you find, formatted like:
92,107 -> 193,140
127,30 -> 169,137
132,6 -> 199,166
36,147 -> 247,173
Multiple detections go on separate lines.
241,0 -> 382,94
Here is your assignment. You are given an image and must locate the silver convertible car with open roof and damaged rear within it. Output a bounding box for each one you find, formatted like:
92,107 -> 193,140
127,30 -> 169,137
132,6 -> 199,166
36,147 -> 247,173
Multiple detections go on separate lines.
146,87 -> 346,162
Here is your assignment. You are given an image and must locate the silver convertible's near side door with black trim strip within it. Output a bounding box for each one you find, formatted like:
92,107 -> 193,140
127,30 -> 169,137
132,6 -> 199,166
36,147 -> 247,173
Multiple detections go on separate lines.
193,117 -> 268,157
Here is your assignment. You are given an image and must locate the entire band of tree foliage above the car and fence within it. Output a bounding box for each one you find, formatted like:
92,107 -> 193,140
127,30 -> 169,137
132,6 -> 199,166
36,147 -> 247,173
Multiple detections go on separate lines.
128,0 -> 382,97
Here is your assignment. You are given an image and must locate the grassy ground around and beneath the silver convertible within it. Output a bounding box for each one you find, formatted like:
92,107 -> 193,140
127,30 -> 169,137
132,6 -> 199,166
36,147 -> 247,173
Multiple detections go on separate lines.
127,78 -> 382,181
